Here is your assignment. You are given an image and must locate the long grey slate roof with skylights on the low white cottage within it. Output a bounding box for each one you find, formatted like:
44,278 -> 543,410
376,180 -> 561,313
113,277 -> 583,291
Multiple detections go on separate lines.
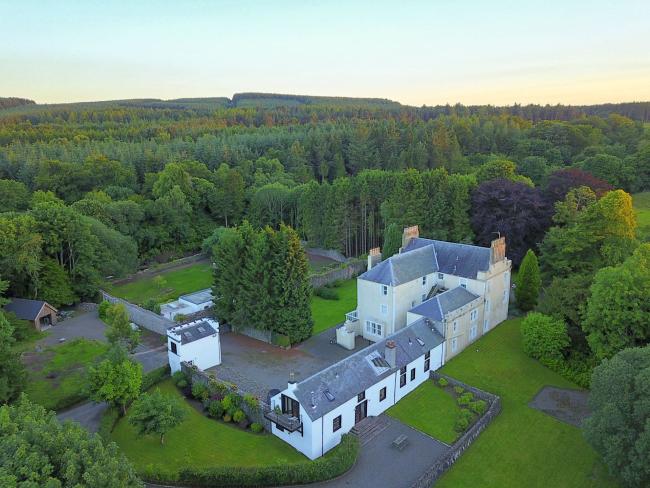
294,318 -> 444,420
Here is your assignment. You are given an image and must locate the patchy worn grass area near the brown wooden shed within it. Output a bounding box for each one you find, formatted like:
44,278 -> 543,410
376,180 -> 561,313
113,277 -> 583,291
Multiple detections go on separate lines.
23,339 -> 108,410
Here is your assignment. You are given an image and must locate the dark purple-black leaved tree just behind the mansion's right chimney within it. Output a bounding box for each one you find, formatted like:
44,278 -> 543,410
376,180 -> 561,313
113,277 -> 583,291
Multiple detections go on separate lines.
471,179 -> 551,265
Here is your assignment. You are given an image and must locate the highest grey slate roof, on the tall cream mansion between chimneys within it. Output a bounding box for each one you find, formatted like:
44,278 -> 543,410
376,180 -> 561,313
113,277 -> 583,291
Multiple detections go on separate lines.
359,237 -> 491,286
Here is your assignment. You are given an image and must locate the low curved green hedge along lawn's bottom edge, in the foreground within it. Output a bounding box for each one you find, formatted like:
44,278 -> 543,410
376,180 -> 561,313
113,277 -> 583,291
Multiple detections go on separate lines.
141,434 -> 359,487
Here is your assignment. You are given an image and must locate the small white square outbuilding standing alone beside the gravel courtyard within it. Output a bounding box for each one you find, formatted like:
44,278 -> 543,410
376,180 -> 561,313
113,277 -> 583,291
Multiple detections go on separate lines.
167,319 -> 221,373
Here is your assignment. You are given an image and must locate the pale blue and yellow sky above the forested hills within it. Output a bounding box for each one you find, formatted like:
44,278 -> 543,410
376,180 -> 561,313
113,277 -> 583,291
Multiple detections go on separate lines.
0,0 -> 650,106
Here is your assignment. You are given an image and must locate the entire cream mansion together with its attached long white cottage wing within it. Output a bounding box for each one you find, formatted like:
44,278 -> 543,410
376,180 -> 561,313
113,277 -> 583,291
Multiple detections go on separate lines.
267,226 -> 511,459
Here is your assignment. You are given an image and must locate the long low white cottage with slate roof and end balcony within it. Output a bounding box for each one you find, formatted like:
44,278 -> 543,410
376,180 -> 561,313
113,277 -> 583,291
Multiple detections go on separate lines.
266,318 -> 445,459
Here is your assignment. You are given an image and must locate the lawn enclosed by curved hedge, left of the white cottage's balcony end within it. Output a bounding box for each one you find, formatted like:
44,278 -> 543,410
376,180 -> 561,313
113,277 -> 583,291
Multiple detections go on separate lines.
112,380 -> 307,473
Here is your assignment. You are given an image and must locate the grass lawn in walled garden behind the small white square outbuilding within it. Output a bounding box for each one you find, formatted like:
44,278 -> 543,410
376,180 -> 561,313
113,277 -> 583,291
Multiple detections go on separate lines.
106,263 -> 212,305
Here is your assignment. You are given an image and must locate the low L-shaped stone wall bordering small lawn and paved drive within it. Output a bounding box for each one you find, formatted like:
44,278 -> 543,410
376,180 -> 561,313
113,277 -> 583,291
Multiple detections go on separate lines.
411,371 -> 501,488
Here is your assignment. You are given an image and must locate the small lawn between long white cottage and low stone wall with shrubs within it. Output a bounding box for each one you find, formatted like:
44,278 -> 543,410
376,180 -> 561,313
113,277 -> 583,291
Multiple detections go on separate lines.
386,381 -> 460,444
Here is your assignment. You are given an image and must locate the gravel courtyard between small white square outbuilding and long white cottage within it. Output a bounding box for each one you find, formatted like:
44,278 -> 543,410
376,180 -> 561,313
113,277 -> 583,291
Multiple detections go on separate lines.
208,329 -> 369,399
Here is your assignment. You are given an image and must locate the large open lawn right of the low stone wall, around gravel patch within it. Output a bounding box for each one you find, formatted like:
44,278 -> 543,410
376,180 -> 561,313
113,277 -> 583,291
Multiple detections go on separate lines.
436,319 -> 617,488
